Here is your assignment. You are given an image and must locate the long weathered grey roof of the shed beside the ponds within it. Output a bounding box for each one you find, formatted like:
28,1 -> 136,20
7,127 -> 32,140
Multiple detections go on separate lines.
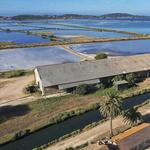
37,54 -> 150,87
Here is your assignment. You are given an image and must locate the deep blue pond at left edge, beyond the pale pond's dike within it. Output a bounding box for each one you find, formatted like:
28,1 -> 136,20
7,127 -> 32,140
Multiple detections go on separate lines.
0,32 -> 49,44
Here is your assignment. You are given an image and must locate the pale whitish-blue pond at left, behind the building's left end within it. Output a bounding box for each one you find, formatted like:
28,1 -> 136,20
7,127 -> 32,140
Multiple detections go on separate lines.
0,46 -> 80,71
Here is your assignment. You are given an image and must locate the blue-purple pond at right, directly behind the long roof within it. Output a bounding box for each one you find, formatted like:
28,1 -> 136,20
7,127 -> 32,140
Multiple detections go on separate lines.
70,40 -> 150,55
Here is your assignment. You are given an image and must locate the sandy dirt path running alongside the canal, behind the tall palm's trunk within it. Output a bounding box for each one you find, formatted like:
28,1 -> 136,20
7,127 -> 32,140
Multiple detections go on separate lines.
46,104 -> 150,150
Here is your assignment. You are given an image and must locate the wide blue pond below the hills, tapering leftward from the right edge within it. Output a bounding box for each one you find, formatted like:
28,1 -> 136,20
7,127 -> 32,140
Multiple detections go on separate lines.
44,19 -> 150,34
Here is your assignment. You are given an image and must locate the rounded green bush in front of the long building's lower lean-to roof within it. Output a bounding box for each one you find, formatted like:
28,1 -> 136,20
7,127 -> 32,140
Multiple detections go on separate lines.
75,84 -> 88,95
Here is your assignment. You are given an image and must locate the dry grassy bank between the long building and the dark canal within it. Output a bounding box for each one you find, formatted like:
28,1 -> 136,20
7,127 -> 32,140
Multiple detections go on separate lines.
0,84 -> 150,144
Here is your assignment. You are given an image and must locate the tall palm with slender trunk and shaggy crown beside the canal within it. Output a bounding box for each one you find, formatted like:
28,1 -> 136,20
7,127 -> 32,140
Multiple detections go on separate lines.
100,89 -> 122,136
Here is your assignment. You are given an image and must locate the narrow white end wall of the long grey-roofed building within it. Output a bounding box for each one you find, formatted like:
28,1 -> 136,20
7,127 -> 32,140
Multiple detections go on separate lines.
34,69 -> 45,95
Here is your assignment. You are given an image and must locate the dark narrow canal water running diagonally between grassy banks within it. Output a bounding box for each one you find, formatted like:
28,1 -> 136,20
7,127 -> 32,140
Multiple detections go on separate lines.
0,93 -> 150,150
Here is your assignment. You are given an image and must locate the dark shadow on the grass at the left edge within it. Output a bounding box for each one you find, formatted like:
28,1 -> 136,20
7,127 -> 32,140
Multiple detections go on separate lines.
0,105 -> 30,123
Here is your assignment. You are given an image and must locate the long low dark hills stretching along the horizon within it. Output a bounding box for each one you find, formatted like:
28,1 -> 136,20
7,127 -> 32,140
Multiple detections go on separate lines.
2,13 -> 150,20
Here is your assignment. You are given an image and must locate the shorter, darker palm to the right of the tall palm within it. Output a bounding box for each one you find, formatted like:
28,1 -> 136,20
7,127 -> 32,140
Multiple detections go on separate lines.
122,107 -> 142,126
